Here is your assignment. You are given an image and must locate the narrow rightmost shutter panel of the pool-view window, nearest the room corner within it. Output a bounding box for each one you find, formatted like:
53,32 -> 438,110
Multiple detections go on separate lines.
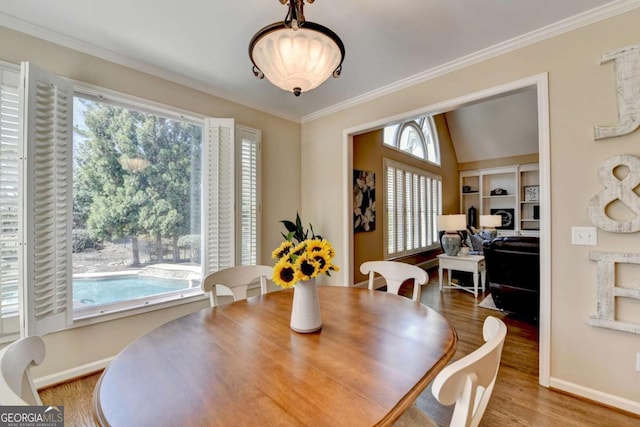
236,126 -> 261,265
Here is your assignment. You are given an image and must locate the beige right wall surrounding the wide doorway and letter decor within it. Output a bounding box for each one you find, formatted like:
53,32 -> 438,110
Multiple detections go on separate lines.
302,9 -> 640,412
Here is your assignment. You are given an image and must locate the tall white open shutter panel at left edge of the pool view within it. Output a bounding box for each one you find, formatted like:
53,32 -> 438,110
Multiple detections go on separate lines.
21,62 -> 73,335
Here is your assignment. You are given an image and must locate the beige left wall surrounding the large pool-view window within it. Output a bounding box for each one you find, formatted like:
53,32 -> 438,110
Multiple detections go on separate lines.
0,27 -> 301,377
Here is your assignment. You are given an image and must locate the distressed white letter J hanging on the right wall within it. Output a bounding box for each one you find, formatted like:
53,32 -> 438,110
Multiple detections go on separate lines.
594,44 -> 640,140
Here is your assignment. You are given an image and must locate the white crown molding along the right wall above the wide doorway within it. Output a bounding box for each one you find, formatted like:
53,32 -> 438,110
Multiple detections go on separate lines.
301,0 -> 640,124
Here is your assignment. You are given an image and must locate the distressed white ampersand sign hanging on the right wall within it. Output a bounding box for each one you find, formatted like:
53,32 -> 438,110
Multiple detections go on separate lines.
587,154 -> 640,233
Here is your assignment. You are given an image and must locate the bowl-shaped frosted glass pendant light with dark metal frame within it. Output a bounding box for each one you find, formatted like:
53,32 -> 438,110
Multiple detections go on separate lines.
249,0 -> 344,96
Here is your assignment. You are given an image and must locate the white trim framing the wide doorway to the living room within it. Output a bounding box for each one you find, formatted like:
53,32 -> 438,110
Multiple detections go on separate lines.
342,73 -> 551,387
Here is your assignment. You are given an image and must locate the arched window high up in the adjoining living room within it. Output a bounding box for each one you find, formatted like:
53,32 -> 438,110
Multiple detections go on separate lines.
383,116 -> 440,165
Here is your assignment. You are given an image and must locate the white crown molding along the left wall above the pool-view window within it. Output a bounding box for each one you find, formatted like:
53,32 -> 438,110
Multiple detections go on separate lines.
0,12 -> 300,123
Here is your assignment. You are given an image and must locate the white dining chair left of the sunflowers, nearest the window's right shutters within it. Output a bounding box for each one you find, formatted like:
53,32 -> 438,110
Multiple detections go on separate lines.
201,265 -> 273,307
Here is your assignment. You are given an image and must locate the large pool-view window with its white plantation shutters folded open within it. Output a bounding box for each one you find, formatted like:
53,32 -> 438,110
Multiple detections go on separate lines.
0,63 -> 261,341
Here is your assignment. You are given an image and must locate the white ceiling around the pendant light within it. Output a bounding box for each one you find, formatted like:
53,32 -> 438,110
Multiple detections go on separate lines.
0,0 -> 628,120
